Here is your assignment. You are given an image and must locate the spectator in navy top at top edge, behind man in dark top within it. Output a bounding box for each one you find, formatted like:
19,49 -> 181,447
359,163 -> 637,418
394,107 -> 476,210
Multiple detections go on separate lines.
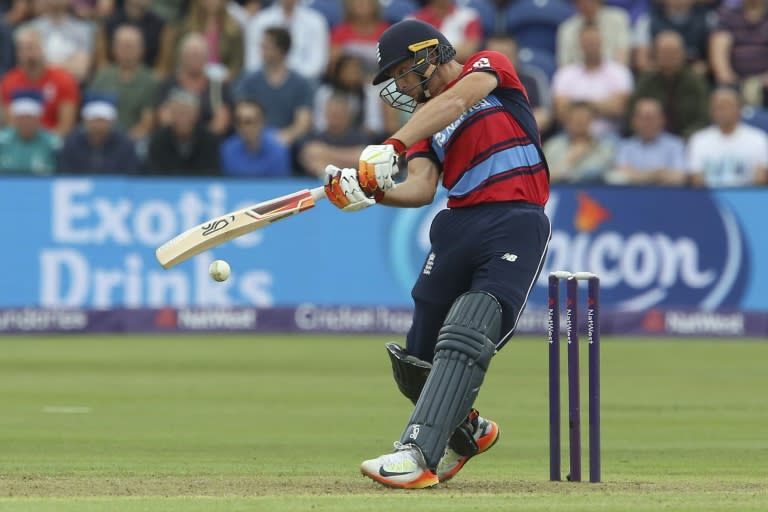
633,0 -> 717,75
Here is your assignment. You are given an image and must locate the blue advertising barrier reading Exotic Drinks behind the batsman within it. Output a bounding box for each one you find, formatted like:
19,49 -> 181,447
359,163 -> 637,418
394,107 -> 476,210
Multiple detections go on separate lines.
0,177 -> 768,336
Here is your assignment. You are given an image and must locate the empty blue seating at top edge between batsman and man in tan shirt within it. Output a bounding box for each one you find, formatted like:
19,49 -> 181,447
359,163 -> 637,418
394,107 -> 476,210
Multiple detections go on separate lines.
503,0 -> 573,55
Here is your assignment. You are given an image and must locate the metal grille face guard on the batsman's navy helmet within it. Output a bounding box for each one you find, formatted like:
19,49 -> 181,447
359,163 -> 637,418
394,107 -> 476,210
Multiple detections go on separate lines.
379,39 -> 456,114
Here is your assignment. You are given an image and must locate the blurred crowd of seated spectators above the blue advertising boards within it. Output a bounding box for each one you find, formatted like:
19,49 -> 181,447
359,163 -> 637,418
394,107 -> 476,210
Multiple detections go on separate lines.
0,0 -> 768,187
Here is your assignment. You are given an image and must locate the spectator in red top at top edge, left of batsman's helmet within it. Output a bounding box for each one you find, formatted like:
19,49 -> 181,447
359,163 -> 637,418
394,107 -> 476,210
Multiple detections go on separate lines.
328,0 -> 389,75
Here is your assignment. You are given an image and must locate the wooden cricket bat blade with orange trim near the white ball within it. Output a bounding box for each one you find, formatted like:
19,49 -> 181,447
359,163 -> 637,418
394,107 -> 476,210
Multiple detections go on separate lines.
155,187 -> 325,269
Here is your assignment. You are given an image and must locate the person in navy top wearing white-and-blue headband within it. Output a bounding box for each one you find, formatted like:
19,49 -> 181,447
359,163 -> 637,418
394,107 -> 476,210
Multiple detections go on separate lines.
57,94 -> 139,174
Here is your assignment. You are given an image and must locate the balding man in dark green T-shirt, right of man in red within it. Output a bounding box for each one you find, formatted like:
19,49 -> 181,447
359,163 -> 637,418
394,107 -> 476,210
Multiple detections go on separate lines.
90,25 -> 158,141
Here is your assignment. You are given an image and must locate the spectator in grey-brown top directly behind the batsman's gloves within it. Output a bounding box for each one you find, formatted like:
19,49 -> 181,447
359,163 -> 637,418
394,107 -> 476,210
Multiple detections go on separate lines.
299,94 -> 372,178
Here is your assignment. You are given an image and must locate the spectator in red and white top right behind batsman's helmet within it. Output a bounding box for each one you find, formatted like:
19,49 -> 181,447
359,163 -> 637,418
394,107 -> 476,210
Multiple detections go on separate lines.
413,0 -> 484,62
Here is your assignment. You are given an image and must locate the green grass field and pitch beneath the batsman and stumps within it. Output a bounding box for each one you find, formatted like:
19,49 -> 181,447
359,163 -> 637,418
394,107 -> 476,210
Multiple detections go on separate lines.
0,335 -> 768,512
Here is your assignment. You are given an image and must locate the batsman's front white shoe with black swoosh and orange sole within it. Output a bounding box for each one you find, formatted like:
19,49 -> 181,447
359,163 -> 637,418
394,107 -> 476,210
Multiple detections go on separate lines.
360,442 -> 440,489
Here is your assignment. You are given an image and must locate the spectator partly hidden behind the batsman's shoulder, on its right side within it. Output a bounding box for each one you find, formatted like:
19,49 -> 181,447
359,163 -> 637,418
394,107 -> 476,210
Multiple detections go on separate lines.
485,34 -> 552,136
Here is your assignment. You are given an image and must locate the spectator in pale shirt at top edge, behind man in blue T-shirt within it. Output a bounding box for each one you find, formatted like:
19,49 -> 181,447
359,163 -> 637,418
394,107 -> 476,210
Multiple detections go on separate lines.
245,0 -> 330,80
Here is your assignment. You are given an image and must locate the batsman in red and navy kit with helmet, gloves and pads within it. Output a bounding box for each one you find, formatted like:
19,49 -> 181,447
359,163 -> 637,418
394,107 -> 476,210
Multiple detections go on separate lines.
325,20 -> 551,489
